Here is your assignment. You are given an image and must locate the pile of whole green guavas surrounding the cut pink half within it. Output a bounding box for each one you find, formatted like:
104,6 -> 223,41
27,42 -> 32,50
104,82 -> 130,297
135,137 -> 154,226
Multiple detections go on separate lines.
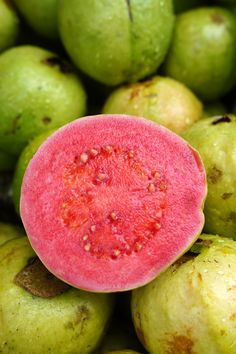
0,0 -> 236,354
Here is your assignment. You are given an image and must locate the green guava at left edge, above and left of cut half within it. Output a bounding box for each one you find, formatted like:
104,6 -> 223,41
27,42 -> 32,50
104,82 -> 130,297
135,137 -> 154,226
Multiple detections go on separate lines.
0,45 -> 86,156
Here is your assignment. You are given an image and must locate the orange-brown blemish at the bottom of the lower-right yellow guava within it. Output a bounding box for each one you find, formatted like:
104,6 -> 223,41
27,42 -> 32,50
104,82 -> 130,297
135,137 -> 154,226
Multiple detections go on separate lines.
166,335 -> 194,354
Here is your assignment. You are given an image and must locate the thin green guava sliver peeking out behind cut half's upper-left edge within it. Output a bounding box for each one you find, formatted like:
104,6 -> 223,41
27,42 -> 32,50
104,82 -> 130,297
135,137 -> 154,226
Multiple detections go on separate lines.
12,130 -> 54,214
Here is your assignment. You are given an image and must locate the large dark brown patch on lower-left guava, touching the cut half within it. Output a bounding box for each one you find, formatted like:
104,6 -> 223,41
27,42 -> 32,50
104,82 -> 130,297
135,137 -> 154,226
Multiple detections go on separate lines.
14,257 -> 70,299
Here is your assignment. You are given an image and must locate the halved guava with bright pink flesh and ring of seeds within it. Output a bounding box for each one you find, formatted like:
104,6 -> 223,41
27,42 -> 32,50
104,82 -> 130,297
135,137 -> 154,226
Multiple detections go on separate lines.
21,115 -> 206,292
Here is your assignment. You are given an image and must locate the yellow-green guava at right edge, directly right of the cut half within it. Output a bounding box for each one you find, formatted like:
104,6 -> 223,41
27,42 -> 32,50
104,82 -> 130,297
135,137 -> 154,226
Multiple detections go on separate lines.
183,115 -> 236,238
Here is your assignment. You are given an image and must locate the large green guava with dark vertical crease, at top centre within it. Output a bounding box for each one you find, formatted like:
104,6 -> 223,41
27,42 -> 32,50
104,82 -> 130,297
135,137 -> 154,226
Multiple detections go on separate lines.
58,0 -> 174,86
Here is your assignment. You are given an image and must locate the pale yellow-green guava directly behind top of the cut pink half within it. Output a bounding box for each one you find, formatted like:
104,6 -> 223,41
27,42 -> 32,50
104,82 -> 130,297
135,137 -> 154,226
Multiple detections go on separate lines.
103,76 -> 203,134
